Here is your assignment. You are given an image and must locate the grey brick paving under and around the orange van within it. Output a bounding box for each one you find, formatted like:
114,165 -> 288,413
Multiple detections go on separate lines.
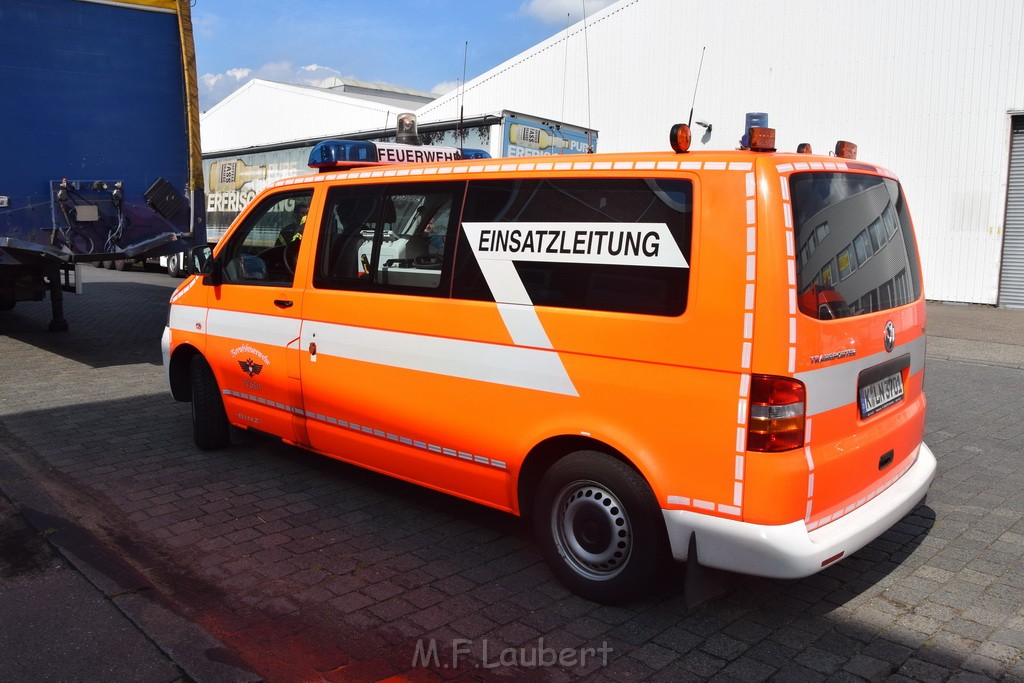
0,269 -> 1024,681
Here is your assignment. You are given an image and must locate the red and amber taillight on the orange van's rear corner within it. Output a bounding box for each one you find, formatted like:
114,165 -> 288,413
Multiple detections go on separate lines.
746,375 -> 807,453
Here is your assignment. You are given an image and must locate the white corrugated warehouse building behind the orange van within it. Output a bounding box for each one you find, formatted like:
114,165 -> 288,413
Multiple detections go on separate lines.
203,0 -> 1024,306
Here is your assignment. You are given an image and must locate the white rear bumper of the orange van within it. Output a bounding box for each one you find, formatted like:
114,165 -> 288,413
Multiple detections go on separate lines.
662,442 -> 936,579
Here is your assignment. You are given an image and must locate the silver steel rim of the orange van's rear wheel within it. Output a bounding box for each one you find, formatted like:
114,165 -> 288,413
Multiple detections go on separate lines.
551,481 -> 633,581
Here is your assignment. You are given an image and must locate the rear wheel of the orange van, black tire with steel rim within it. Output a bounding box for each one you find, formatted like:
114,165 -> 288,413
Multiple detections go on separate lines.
534,451 -> 668,604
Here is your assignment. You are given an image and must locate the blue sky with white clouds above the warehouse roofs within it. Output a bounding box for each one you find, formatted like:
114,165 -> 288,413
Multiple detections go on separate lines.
191,0 -> 614,111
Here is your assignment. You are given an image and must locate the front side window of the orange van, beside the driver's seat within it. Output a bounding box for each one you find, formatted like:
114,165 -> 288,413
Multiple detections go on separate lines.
222,189 -> 312,287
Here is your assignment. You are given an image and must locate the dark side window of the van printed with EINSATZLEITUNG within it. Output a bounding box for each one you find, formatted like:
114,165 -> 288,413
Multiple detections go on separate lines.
453,178 -> 693,315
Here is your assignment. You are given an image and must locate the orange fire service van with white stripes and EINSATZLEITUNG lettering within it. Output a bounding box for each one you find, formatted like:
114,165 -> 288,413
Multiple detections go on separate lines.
163,118 -> 936,602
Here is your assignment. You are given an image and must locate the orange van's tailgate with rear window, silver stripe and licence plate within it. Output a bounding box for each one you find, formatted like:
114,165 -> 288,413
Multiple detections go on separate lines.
787,169 -> 925,528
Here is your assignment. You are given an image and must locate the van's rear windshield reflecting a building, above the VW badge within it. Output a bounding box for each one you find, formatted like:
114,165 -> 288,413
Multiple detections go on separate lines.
790,172 -> 921,319
